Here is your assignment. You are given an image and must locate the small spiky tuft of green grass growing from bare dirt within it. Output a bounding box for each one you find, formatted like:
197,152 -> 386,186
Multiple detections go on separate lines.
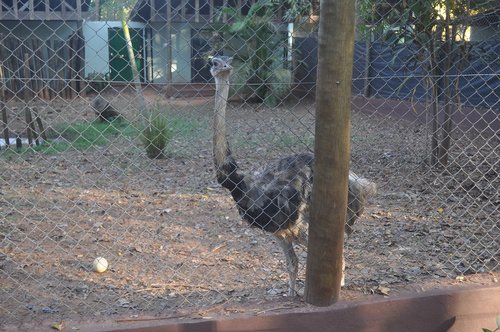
141,109 -> 172,159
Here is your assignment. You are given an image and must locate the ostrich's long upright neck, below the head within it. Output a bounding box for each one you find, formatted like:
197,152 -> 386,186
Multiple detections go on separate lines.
213,77 -> 245,201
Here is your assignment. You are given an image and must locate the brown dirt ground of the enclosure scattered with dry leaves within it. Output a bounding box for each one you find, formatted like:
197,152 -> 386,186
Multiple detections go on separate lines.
0,91 -> 500,329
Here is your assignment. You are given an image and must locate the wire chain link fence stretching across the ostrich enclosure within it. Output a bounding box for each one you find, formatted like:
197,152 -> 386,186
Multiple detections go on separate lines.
0,0 -> 500,326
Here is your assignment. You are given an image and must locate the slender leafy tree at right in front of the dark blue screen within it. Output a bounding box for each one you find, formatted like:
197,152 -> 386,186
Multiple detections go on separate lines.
358,0 -> 496,167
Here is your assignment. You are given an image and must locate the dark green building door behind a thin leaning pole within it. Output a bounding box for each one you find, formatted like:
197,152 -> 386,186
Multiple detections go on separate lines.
108,28 -> 144,82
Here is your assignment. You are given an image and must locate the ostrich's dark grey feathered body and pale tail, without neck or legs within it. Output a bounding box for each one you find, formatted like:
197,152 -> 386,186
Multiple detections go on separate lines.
220,152 -> 376,245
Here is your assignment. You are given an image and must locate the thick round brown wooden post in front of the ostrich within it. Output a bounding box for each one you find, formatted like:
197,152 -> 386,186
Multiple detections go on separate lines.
305,0 -> 355,306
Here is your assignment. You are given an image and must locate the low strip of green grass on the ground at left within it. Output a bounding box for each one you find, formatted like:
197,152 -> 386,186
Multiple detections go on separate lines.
0,107 -> 207,161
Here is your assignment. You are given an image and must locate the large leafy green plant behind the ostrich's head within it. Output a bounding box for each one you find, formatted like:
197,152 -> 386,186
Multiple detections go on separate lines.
221,0 -> 292,106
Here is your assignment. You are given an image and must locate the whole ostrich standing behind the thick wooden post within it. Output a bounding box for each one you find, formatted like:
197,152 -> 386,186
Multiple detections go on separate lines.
210,56 -> 376,296
